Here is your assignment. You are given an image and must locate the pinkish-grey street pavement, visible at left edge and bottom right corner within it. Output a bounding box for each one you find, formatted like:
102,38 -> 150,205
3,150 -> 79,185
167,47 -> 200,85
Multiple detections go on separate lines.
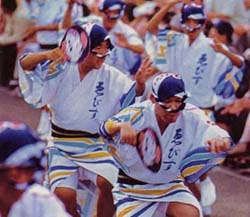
0,87 -> 250,217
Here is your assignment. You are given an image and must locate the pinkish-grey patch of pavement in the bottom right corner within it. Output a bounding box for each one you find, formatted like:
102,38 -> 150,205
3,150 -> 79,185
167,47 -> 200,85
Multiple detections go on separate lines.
210,167 -> 250,217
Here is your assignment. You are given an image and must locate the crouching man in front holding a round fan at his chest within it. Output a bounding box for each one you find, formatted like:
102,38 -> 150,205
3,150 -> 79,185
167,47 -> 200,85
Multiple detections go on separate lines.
100,73 -> 231,217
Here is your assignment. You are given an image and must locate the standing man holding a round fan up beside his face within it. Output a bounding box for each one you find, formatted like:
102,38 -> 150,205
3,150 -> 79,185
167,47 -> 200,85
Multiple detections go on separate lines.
20,23 -> 154,217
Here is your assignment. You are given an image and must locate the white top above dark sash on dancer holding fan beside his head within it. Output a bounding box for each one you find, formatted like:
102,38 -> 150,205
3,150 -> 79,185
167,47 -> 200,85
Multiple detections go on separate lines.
20,61 -> 134,133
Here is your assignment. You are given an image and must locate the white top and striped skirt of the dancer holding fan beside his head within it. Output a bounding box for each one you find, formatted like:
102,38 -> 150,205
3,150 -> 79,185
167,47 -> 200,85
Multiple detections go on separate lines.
19,60 -> 135,216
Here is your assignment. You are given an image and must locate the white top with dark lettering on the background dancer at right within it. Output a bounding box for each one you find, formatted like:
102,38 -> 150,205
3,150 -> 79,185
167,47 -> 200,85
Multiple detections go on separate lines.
154,30 -> 244,108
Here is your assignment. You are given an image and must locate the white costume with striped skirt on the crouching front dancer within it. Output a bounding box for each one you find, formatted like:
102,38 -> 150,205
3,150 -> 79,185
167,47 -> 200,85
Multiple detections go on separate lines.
100,100 -> 229,217
